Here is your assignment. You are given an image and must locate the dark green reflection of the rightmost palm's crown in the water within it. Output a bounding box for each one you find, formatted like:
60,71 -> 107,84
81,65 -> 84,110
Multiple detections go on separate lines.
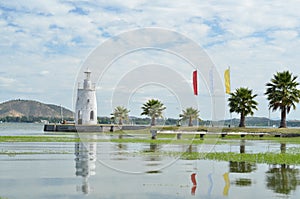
266,164 -> 300,194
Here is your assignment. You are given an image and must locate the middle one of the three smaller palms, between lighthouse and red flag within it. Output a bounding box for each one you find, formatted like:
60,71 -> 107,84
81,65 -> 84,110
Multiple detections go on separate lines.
141,99 -> 166,126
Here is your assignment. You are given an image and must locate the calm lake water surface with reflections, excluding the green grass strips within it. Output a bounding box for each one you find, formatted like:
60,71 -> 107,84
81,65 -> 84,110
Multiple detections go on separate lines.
0,123 -> 300,199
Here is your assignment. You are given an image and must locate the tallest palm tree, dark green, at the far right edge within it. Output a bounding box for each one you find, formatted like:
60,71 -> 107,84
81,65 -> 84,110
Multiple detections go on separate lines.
265,71 -> 300,128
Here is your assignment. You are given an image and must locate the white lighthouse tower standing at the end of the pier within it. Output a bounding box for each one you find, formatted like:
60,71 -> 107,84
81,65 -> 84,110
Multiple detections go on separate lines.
75,69 -> 97,125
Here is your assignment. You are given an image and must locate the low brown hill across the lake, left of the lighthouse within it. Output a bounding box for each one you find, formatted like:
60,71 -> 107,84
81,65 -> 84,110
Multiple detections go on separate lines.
0,99 -> 74,118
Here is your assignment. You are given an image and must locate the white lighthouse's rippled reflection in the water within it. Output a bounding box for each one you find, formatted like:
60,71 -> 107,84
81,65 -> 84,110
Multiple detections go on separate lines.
75,135 -> 97,194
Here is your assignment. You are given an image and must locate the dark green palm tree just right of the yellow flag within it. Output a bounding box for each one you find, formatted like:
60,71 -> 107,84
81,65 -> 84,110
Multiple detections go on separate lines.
228,87 -> 258,127
